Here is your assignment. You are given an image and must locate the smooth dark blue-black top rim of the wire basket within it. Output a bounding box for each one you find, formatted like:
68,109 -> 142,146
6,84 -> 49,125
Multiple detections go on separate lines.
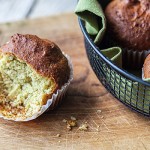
78,17 -> 150,87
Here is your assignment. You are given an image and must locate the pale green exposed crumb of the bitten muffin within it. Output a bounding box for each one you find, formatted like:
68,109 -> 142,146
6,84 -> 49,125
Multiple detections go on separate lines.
0,54 -> 55,118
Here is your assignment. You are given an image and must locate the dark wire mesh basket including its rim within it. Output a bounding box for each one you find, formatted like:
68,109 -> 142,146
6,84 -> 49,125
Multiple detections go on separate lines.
79,18 -> 150,116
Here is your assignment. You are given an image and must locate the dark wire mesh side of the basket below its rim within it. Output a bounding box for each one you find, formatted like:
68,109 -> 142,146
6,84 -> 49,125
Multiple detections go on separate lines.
85,38 -> 150,116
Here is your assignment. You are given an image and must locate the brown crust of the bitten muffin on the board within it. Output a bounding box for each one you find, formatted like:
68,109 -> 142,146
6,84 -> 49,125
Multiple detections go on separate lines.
1,34 -> 70,88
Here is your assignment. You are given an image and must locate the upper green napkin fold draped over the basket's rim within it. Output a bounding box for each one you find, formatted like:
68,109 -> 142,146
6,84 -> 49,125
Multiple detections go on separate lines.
75,0 -> 106,43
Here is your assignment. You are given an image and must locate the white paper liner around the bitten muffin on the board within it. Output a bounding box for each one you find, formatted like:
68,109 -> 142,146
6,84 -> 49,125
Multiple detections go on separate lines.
0,52 -> 73,122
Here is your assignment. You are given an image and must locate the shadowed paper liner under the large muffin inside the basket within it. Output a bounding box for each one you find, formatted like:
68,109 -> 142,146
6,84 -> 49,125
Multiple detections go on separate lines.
122,48 -> 150,70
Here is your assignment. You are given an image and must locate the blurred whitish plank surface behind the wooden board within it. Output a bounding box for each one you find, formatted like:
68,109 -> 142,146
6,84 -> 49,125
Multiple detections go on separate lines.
0,0 -> 77,23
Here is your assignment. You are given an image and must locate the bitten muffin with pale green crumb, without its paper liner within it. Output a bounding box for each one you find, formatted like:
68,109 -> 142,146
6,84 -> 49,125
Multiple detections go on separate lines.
0,34 -> 70,120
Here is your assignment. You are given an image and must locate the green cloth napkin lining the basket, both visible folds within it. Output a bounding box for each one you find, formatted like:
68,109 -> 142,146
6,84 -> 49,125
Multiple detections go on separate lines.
75,0 -> 122,67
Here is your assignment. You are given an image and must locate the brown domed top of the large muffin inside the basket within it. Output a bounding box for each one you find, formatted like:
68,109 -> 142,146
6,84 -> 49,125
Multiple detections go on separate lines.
105,0 -> 150,51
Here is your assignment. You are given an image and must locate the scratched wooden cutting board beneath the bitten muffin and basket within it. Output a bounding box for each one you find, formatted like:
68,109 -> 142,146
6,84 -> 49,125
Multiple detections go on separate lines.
0,14 -> 150,150
